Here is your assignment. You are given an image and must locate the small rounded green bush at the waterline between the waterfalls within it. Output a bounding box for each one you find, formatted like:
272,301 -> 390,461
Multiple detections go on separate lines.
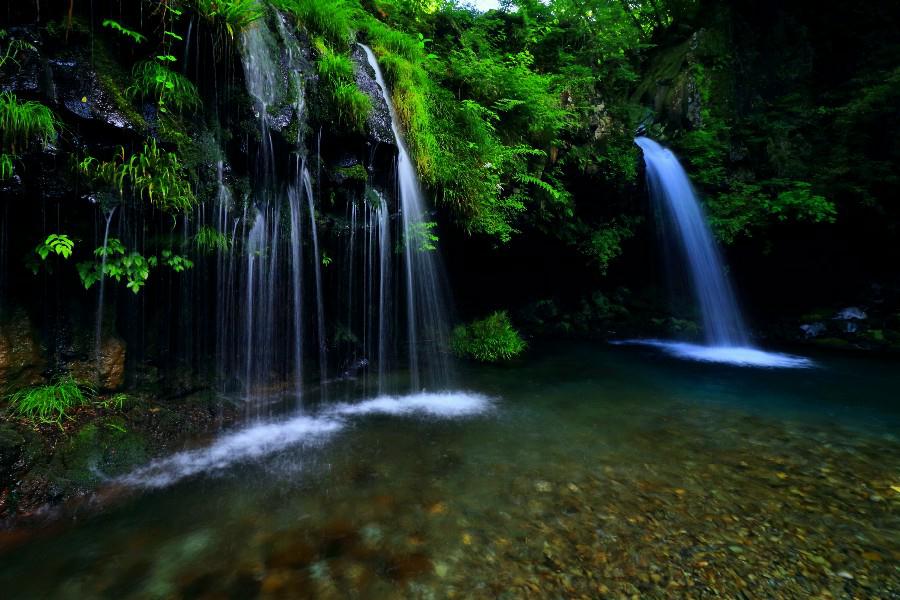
450,310 -> 527,363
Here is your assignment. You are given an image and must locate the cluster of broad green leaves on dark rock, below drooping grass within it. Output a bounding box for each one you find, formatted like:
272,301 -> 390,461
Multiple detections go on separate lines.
77,238 -> 194,294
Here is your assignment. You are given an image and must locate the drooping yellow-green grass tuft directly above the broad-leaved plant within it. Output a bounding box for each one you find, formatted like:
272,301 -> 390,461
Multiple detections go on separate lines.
78,139 -> 197,212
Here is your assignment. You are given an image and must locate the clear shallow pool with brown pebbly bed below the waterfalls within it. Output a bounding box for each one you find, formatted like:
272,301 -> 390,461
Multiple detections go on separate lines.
0,344 -> 900,599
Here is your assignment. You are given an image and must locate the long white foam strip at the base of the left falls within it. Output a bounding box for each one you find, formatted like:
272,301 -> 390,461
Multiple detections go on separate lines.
119,392 -> 491,488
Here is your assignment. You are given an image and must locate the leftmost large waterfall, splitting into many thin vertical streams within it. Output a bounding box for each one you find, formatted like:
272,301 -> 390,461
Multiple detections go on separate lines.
211,14 -> 327,406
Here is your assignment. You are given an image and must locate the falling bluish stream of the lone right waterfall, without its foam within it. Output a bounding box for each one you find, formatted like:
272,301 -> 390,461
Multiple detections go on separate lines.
635,137 -> 749,346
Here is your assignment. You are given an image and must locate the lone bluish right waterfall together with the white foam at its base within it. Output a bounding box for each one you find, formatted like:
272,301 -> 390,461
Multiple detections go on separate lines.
634,137 -> 809,367
